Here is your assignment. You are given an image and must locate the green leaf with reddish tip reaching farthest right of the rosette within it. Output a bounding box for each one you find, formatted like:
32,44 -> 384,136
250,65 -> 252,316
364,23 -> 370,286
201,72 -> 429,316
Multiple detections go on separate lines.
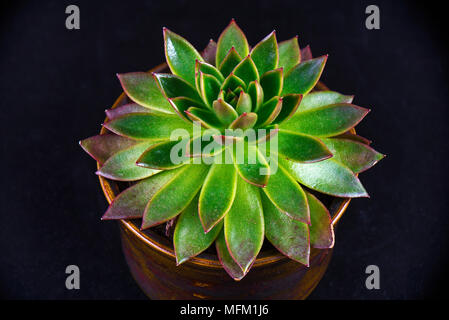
323,138 -> 384,173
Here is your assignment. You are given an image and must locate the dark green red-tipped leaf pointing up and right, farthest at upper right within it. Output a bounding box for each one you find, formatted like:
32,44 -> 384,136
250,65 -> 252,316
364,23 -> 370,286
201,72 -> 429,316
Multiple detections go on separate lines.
282,56 -> 327,94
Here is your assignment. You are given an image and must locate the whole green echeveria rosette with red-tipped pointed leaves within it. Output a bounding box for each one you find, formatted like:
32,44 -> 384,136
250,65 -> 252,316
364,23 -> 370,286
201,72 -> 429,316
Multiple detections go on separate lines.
81,21 -> 383,280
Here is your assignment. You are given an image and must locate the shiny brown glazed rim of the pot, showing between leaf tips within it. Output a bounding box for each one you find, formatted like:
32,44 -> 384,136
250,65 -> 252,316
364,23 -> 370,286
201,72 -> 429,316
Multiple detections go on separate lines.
97,63 -> 355,269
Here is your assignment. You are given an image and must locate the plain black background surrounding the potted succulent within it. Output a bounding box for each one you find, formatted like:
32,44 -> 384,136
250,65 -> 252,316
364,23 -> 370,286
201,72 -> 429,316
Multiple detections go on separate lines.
0,0 -> 449,299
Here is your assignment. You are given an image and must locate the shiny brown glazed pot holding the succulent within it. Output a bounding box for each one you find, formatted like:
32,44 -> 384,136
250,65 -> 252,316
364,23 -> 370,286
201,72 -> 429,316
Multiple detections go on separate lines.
98,64 -> 350,299
